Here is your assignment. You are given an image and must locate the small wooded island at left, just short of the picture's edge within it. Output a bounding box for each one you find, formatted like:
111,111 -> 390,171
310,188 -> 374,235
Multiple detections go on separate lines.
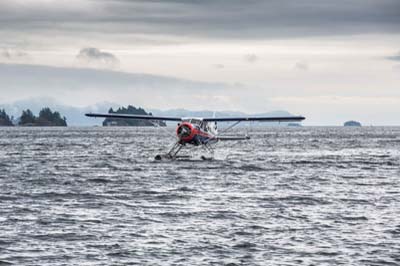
18,107 -> 67,127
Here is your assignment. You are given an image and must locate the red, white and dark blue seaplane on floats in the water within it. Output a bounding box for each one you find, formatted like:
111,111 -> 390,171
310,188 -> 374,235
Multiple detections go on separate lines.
85,113 -> 305,160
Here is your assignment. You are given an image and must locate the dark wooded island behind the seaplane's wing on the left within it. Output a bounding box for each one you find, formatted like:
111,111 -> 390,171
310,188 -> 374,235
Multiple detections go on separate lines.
103,105 -> 167,127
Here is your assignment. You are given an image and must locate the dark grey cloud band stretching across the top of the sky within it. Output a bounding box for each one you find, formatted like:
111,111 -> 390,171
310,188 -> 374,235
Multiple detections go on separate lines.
0,0 -> 400,38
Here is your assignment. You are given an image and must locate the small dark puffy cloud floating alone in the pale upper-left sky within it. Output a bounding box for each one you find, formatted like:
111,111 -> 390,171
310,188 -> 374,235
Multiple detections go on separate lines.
76,47 -> 119,68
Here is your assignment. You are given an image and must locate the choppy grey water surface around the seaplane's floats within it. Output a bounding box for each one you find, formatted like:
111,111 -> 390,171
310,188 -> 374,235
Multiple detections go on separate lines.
0,128 -> 400,265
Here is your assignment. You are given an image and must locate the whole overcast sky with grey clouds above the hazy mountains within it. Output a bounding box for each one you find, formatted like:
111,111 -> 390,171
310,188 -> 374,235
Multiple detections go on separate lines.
0,0 -> 400,125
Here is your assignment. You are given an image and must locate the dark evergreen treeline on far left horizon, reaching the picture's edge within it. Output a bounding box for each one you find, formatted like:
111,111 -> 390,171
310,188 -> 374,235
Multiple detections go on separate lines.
0,107 -> 67,127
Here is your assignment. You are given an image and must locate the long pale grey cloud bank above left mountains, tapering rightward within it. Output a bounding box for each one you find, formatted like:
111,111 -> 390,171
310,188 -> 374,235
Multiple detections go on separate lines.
0,64 -> 231,108
